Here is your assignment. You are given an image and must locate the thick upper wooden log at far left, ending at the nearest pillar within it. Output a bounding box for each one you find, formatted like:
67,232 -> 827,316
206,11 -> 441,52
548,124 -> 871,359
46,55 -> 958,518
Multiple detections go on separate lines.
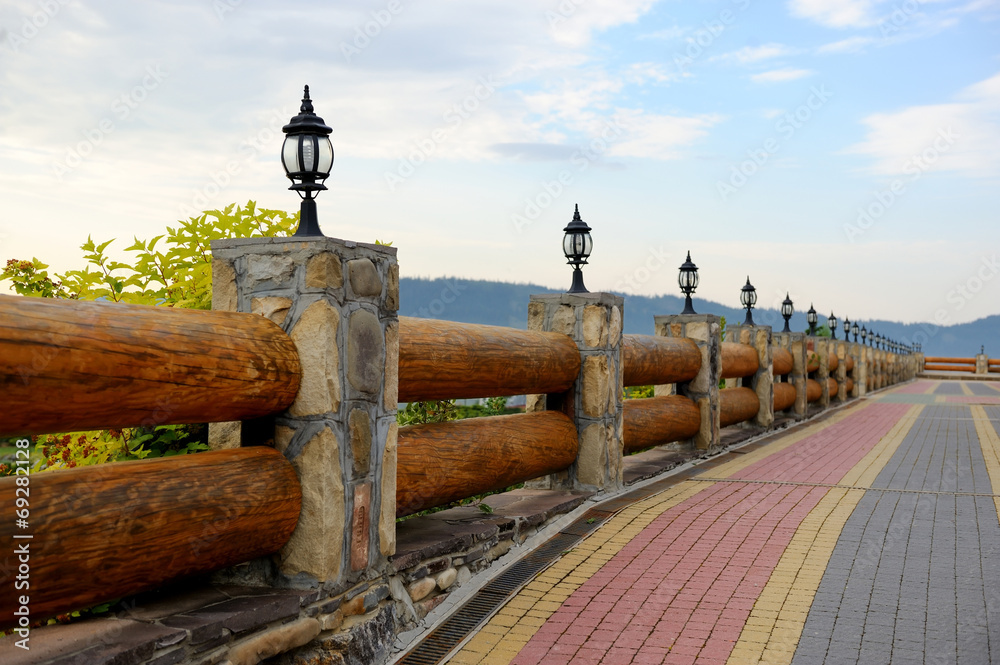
0,296 -> 299,436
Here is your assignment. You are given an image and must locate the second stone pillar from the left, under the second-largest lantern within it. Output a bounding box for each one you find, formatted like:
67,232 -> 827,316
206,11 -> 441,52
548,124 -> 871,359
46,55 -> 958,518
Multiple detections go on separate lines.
526,293 -> 625,490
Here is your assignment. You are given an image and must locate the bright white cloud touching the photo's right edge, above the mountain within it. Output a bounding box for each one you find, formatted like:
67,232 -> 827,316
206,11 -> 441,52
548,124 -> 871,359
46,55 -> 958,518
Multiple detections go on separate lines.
845,74 -> 1000,177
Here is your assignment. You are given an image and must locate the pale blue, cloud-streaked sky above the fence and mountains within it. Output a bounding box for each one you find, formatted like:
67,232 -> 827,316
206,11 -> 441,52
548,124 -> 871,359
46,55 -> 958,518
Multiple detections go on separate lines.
0,0 -> 1000,323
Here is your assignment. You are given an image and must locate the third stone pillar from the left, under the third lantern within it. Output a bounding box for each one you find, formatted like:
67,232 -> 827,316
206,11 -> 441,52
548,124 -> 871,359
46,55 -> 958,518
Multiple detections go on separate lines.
653,314 -> 722,450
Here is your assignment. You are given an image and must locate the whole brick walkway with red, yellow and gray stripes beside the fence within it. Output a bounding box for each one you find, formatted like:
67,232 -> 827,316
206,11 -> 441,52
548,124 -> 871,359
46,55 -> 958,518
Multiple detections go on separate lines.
450,380 -> 1000,665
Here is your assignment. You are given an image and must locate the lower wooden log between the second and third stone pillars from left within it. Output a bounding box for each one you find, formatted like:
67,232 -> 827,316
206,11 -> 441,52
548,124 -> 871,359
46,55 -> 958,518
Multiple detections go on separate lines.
622,395 -> 701,452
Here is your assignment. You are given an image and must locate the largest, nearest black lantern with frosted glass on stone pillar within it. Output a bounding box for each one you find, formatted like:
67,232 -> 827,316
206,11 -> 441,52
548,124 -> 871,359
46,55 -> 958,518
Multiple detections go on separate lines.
281,86 -> 333,237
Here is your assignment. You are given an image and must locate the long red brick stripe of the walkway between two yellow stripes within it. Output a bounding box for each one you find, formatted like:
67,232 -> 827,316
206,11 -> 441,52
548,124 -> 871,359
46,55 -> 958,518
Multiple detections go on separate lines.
512,404 -> 910,665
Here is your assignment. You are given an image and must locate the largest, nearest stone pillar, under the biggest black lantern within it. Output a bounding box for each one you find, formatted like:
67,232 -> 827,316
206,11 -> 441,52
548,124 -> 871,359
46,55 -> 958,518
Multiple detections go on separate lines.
210,237 -> 399,591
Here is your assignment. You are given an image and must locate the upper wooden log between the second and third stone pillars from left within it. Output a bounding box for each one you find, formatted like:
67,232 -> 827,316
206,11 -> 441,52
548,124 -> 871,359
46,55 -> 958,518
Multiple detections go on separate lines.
622,335 -> 701,388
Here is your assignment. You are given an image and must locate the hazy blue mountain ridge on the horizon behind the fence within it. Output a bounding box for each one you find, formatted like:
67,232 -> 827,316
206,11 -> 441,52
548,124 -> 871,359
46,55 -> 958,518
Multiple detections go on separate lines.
399,277 -> 1000,357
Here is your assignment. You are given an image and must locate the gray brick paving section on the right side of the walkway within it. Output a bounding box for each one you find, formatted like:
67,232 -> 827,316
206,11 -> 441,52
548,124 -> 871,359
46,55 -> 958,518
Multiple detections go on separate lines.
792,404 -> 1000,665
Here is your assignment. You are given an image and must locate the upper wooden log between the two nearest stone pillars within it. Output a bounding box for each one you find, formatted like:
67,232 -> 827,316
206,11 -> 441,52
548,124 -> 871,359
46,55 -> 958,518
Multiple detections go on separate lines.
399,316 -> 580,402
